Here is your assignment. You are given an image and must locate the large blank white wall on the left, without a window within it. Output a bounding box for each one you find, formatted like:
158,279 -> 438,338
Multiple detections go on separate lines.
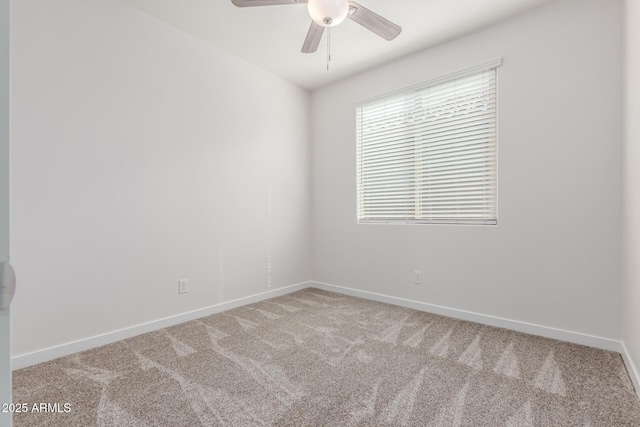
11,0 -> 310,355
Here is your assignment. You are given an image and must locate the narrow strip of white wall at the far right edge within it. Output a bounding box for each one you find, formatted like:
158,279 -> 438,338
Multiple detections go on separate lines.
623,0 -> 640,384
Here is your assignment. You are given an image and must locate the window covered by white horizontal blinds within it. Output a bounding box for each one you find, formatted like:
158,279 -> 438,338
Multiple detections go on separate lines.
356,61 -> 501,224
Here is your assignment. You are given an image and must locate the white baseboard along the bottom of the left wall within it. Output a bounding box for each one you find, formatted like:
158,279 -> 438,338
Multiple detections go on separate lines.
11,282 -> 311,370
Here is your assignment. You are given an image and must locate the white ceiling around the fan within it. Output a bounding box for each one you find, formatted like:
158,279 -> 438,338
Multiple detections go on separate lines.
123,0 -> 553,90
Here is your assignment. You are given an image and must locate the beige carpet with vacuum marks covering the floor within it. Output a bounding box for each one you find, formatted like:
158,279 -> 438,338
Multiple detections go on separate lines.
14,289 -> 640,427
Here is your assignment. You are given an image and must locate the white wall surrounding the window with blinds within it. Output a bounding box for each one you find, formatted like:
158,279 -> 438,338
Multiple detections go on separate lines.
311,0 -> 622,340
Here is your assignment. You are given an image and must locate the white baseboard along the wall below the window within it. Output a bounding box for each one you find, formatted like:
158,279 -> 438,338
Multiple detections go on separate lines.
311,282 -> 623,353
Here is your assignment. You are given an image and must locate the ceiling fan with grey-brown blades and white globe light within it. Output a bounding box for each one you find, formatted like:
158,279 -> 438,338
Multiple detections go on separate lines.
231,0 -> 402,53
